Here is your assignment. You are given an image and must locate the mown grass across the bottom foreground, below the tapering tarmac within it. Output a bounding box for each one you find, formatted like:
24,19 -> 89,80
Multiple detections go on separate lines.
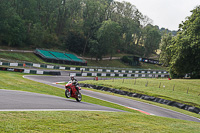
0,111 -> 200,133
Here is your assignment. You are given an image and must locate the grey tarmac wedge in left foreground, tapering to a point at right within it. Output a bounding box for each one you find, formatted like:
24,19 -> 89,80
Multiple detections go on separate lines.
0,89 -> 123,111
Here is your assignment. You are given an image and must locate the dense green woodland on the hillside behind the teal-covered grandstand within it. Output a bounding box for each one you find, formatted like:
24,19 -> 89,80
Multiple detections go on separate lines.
0,0 -> 161,59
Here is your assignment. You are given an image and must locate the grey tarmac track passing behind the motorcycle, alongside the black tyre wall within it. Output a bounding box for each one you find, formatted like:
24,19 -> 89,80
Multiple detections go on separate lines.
24,75 -> 200,122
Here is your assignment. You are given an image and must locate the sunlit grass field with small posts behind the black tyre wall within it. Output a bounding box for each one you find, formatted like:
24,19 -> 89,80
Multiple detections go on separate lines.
80,79 -> 200,107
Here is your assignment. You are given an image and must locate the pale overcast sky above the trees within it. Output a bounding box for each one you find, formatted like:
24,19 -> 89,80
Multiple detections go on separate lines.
116,0 -> 200,30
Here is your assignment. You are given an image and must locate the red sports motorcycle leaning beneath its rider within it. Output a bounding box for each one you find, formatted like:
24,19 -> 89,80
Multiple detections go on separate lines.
65,81 -> 82,102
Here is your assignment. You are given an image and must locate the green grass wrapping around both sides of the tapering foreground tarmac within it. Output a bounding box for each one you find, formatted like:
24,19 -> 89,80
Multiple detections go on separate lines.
0,71 -> 200,133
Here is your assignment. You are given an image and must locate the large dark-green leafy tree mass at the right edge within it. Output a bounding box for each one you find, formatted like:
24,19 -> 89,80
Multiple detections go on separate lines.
160,6 -> 200,78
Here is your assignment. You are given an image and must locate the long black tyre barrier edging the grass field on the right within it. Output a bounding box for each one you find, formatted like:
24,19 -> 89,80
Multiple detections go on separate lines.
79,84 -> 200,114
